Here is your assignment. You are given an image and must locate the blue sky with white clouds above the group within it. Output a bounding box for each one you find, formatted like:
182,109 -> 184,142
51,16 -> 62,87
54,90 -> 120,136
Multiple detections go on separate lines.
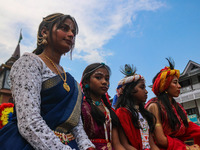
0,0 -> 200,100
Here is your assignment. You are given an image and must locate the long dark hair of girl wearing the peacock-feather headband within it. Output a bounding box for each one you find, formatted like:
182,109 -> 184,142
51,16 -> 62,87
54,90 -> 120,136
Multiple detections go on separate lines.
116,79 -> 156,132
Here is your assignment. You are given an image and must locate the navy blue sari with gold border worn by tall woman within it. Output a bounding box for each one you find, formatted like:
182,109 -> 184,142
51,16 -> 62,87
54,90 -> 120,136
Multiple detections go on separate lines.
0,73 -> 82,150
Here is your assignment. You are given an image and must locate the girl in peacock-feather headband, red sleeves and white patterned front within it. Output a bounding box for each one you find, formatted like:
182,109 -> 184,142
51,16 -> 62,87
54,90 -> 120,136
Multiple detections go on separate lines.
116,65 -> 158,150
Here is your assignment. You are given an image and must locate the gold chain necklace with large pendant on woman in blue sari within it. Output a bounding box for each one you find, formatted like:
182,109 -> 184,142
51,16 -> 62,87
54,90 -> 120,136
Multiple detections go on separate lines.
44,54 -> 70,92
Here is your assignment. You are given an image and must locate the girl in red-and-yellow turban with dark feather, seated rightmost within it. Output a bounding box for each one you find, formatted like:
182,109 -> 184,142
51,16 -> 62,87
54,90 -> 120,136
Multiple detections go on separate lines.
145,59 -> 200,150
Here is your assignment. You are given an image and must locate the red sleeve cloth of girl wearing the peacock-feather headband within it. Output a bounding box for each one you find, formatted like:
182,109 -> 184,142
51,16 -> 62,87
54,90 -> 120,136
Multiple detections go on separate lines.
116,107 -> 150,150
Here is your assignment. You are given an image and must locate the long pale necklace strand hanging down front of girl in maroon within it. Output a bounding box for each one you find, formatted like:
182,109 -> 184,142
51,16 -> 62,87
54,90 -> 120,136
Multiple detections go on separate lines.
103,104 -> 112,150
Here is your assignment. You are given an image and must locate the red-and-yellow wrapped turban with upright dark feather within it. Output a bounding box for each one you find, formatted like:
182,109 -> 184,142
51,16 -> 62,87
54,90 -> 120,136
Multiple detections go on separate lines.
152,58 -> 180,96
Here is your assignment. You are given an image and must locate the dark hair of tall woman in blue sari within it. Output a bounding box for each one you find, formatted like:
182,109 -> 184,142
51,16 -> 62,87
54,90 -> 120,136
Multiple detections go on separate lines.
33,13 -> 78,56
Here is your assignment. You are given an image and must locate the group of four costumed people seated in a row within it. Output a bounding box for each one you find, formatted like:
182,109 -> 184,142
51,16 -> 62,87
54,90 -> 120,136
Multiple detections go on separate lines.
0,13 -> 200,150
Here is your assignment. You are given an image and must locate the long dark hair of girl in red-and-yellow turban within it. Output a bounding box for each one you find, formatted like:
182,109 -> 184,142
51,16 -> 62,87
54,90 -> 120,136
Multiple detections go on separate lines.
152,72 -> 189,131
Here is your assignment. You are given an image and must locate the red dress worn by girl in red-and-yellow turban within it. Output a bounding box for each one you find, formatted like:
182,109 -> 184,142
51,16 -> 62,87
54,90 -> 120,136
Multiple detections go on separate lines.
145,98 -> 200,150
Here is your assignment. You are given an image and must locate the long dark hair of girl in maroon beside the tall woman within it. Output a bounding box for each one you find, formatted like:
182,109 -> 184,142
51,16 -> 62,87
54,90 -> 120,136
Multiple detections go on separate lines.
81,63 -> 119,126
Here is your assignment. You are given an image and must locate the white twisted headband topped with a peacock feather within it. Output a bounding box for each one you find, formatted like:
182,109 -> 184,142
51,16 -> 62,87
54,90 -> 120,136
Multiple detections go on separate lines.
116,64 -> 144,97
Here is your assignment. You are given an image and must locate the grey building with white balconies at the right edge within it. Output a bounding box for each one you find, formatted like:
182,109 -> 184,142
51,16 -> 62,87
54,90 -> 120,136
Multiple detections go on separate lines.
176,60 -> 200,124
